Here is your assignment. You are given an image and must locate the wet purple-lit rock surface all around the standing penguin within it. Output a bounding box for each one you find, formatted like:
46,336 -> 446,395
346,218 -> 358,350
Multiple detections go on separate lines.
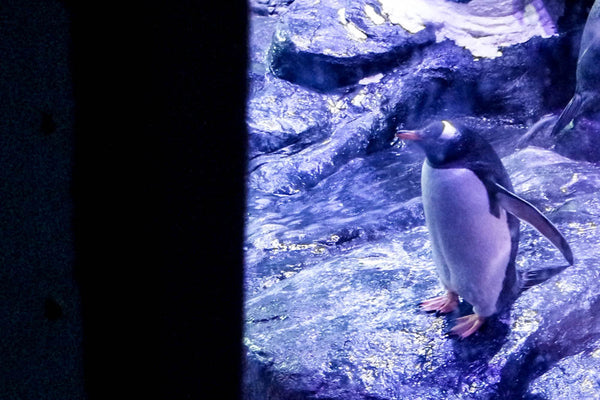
244,0 -> 600,400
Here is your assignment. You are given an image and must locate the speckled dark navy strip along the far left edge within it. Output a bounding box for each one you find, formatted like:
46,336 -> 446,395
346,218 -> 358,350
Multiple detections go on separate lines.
0,1 -> 83,400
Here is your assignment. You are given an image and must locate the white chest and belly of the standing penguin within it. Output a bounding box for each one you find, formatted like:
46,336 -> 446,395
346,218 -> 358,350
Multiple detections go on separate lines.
421,162 -> 511,316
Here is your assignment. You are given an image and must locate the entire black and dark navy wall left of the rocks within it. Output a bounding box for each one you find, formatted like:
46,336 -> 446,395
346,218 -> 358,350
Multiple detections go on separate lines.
0,0 -> 246,400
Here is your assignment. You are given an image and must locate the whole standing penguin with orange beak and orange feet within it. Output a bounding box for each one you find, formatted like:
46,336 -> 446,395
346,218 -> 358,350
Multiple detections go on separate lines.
396,121 -> 573,339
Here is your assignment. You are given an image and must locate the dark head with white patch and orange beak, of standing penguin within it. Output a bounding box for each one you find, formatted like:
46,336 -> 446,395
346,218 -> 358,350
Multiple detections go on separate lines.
396,121 -> 470,165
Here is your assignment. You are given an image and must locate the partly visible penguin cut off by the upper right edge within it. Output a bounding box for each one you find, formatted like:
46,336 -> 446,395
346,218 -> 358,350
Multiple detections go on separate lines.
551,1 -> 600,136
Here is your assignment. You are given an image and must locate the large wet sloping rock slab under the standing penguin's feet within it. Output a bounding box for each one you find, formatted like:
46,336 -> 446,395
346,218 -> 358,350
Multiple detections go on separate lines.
245,148 -> 600,399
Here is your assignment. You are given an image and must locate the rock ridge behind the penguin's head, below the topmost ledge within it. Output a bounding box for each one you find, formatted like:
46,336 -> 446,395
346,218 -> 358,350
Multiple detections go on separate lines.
248,1 -> 576,194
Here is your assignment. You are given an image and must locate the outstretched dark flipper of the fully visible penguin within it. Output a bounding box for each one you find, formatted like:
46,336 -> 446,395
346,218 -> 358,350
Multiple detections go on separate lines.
494,183 -> 573,265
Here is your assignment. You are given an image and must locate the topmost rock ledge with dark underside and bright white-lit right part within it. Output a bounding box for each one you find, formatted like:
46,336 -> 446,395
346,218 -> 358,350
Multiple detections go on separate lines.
271,0 -> 563,91
